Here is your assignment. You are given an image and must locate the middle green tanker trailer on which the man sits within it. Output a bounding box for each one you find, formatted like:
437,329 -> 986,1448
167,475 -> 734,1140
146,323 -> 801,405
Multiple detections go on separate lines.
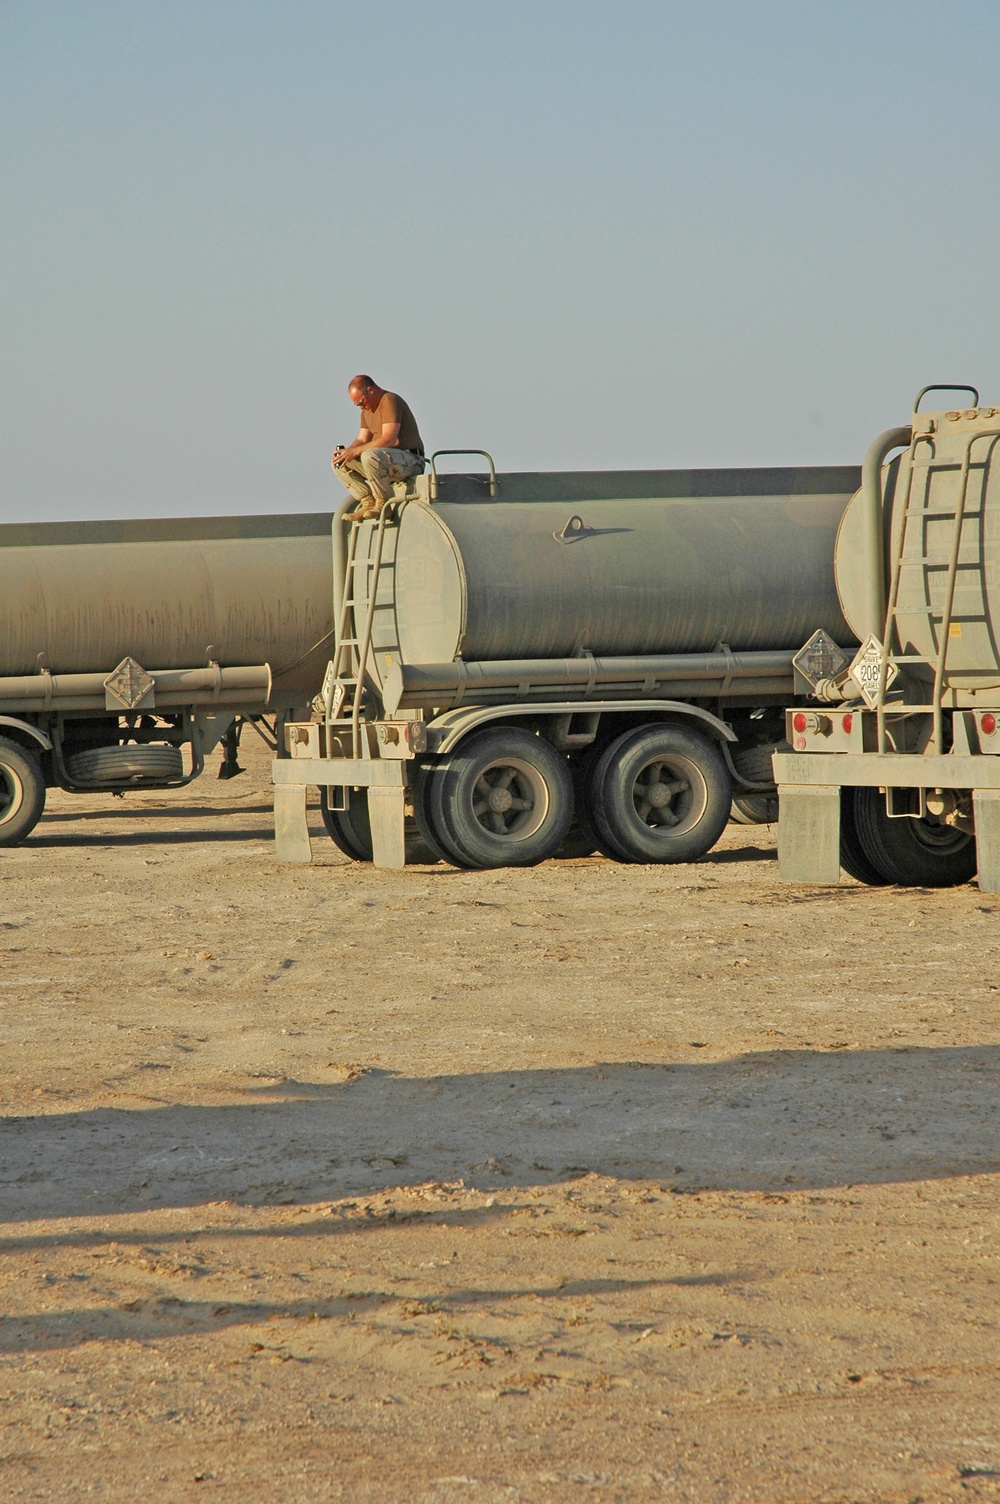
274,451 -> 860,868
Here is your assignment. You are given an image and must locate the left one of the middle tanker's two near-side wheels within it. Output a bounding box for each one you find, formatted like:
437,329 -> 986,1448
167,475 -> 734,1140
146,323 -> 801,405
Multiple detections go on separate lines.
430,726 -> 573,868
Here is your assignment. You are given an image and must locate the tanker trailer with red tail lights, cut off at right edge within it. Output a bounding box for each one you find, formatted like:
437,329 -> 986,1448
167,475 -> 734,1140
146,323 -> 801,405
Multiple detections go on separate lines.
774,385 -> 1000,892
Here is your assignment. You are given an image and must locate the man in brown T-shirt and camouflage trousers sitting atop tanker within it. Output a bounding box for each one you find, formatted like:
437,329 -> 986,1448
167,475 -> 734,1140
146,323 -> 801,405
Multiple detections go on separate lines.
329,376 -> 424,522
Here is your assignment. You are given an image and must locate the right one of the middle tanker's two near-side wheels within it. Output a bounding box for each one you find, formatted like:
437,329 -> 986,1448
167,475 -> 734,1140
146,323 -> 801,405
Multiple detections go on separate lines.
592,725 -> 732,862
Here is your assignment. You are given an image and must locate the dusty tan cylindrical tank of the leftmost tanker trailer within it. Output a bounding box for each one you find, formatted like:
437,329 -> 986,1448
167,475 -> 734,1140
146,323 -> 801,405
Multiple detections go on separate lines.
0,513 -> 332,707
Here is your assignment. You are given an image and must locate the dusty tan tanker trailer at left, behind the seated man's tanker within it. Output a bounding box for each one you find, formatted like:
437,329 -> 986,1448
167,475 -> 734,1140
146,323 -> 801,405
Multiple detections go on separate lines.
0,513 -> 332,845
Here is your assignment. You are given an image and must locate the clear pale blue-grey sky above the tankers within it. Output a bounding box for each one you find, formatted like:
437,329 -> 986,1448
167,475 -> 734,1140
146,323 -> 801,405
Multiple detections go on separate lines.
0,0 -> 1000,522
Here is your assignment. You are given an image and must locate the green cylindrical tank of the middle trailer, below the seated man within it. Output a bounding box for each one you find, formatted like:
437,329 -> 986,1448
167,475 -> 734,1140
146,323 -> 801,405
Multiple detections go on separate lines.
374,466 -> 859,665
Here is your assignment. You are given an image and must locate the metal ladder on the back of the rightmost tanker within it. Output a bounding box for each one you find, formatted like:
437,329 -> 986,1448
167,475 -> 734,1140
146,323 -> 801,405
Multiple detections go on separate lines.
875,433 -> 995,754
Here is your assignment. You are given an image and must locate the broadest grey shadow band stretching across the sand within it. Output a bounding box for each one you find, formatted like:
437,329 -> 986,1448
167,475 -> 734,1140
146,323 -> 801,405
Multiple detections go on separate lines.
0,1045 -> 1000,1221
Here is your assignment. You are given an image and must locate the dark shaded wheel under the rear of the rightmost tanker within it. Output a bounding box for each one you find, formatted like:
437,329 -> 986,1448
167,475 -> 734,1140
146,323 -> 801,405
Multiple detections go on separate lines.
854,788 -> 976,887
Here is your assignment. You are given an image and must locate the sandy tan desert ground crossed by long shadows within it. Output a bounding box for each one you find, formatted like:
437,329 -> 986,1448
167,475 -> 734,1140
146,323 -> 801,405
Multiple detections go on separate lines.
0,733 -> 1000,1504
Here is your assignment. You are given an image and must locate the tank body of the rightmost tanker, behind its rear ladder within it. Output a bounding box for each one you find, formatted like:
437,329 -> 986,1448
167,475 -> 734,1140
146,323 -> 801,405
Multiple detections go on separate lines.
835,408 -> 1000,690
